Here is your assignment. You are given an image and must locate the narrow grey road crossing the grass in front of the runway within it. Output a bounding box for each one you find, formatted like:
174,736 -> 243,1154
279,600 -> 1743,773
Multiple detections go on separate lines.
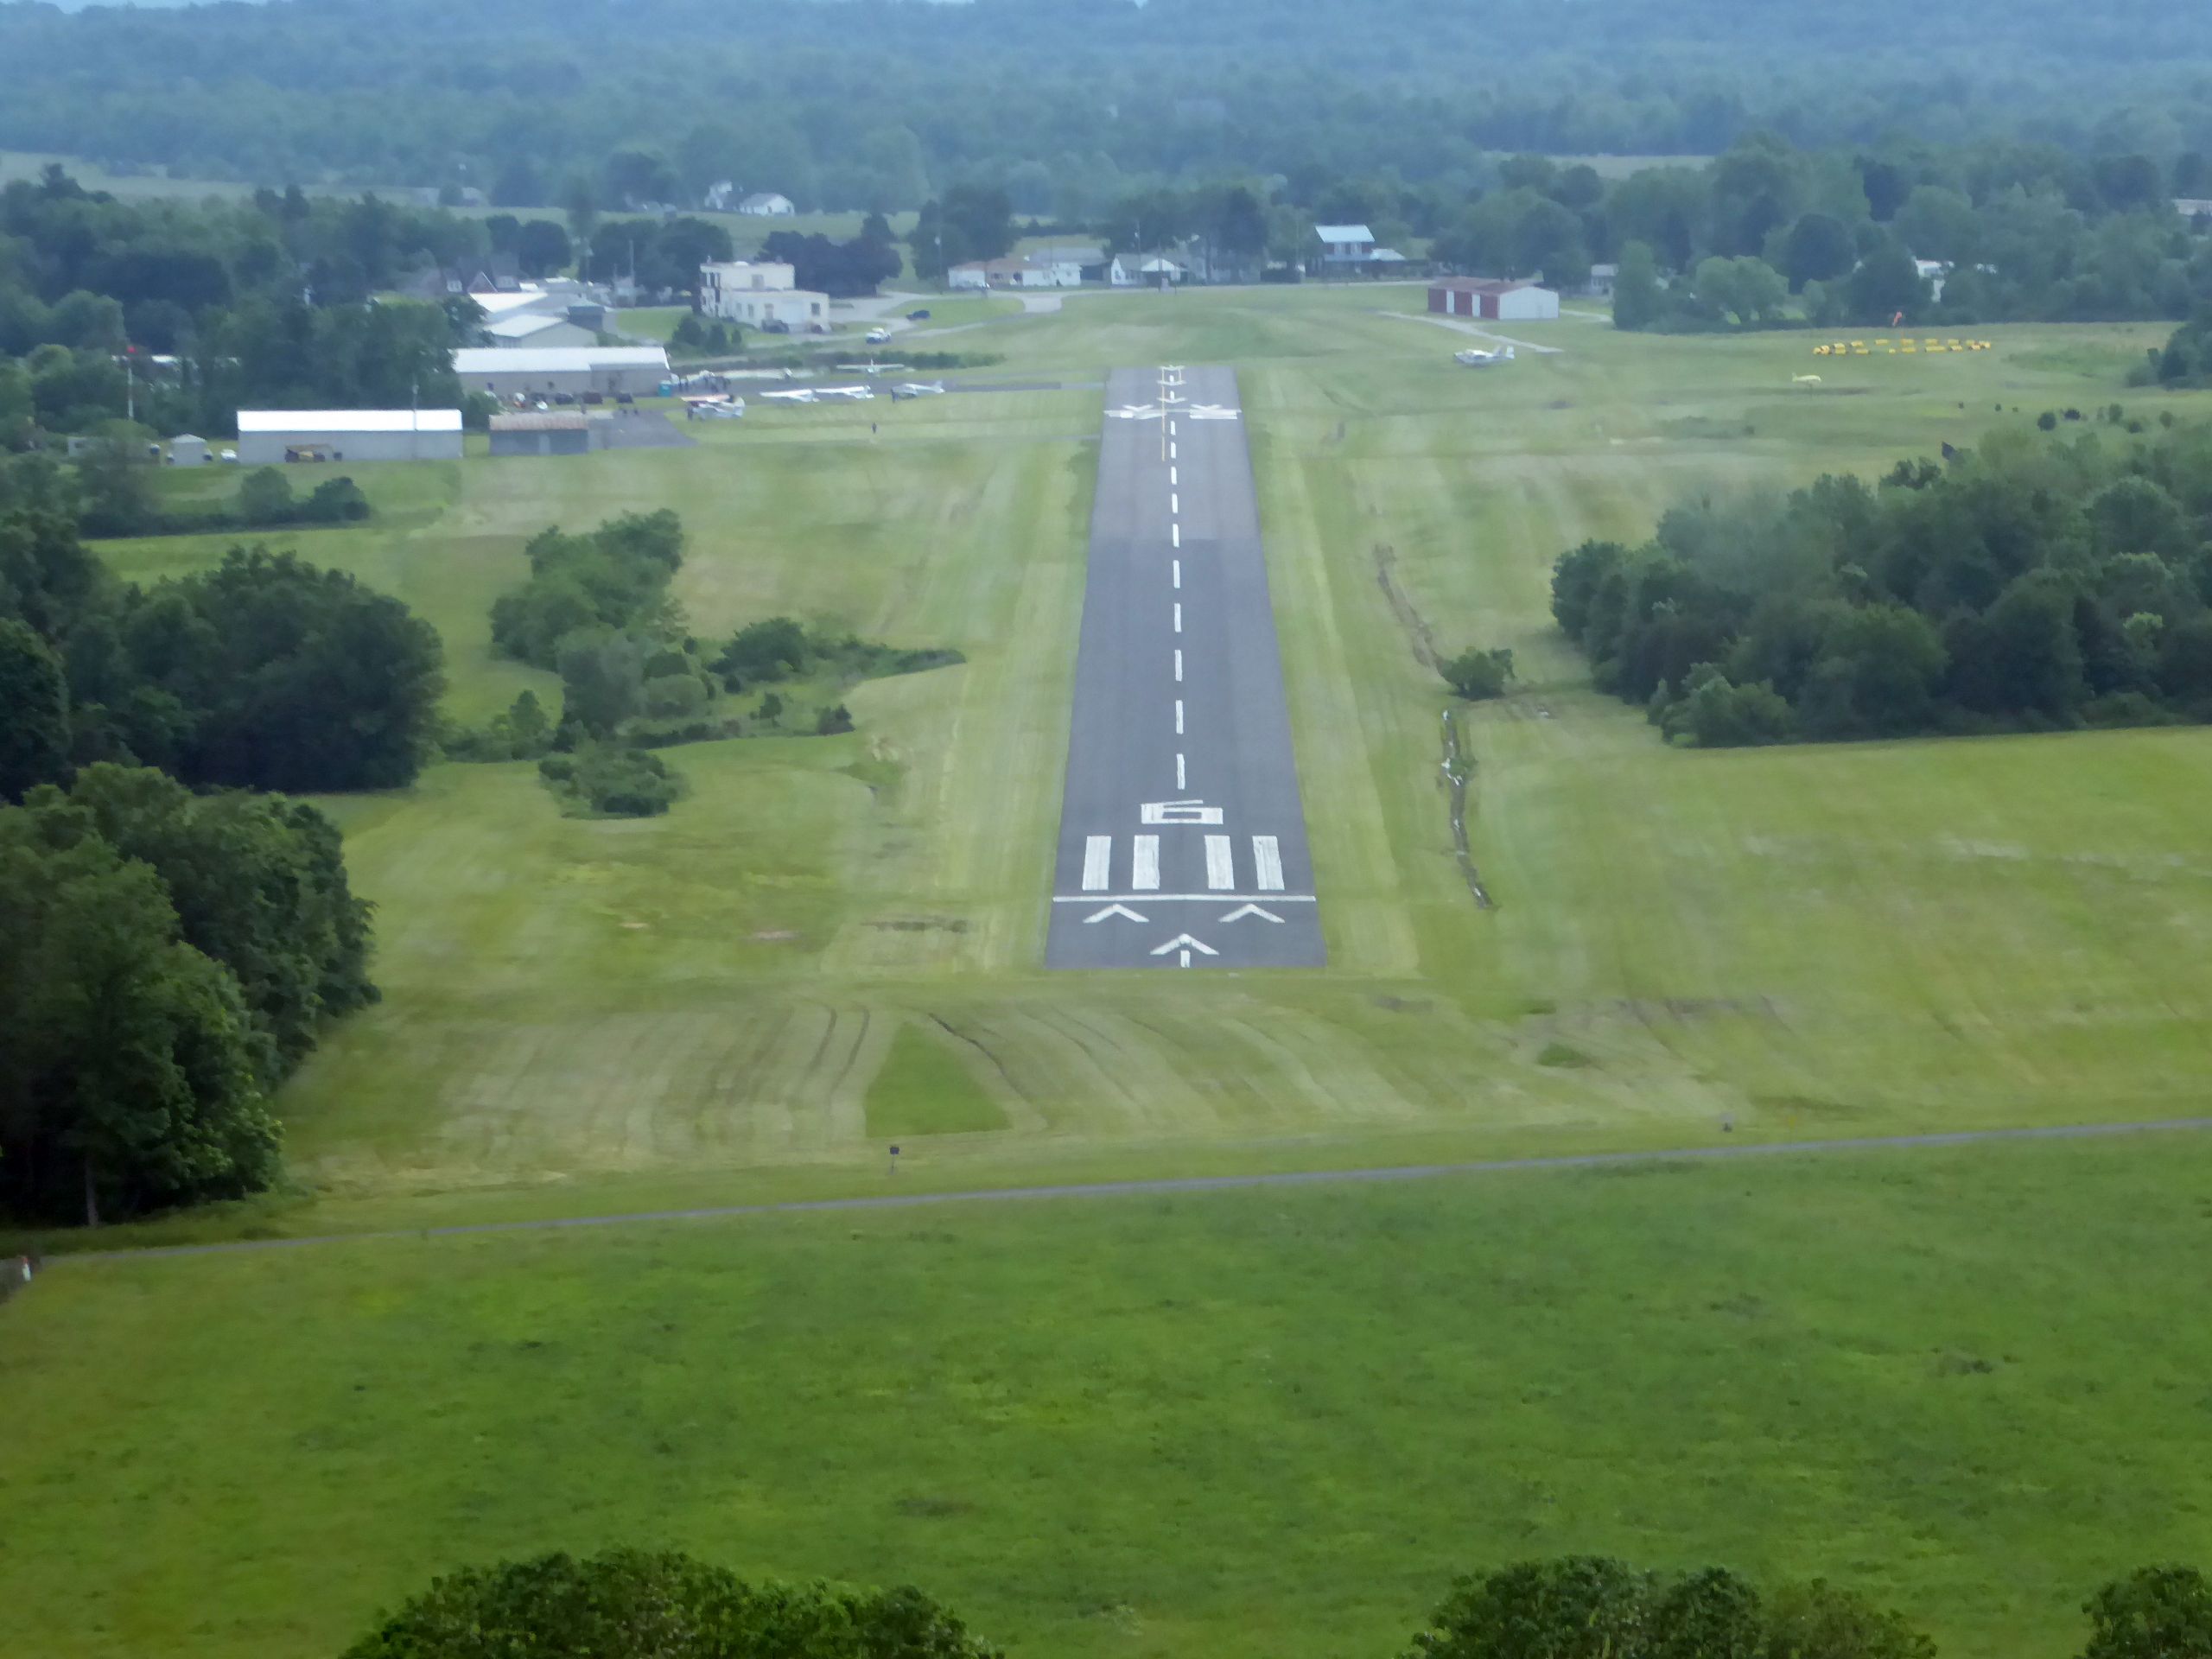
47,1117 -> 2212,1272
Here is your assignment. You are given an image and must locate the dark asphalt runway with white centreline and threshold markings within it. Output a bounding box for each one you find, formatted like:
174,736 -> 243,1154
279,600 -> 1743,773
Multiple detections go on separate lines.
1044,367 -> 1325,969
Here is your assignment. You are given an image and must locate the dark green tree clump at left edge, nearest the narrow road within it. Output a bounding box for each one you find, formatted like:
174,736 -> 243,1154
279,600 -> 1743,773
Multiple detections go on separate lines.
0,765 -> 376,1224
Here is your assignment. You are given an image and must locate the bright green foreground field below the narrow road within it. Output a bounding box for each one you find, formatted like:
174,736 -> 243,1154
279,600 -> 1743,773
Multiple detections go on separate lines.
13,1141 -> 2212,1659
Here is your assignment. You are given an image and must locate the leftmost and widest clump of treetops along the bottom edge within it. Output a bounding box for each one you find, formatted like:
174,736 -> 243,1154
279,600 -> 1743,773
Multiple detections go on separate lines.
345,1551 -> 998,1659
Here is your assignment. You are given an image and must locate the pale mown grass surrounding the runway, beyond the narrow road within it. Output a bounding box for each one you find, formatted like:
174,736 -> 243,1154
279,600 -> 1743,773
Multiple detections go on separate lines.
42,285 -> 2212,1234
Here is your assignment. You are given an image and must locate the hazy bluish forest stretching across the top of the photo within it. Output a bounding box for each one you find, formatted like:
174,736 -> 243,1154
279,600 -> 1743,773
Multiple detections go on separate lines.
0,0 -> 2212,217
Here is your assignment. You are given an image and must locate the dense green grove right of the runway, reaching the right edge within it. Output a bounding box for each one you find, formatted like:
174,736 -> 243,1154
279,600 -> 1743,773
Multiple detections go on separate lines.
1553,427 -> 2212,746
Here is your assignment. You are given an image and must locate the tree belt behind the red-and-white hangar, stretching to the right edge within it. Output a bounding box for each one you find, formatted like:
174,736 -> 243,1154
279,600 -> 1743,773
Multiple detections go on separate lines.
1385,135 -> 2212,327
